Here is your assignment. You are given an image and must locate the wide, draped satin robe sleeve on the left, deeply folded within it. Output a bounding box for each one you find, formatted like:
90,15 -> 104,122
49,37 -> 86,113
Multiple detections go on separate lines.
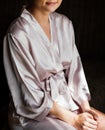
4,34 -> 52,121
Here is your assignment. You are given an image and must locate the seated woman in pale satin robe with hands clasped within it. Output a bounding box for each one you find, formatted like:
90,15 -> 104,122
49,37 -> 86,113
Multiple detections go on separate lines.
4,0 -> 105,130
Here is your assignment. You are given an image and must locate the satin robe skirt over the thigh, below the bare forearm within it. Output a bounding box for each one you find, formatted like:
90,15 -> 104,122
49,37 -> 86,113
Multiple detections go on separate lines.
25,117 -> 76,130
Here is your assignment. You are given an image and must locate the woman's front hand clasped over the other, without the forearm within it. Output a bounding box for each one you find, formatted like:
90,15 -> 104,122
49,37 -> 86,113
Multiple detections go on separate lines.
73,112 -> 98,130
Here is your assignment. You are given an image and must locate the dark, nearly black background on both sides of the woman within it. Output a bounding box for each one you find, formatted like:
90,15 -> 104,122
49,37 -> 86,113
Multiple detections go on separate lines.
0,0 -> 105,127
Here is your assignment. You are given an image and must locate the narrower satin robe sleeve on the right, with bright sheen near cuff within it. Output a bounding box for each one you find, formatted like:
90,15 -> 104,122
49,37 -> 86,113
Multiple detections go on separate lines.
68,22 -> 91,105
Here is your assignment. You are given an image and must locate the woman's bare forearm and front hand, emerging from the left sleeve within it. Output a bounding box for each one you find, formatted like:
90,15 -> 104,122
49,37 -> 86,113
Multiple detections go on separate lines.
49,102 -> 97,130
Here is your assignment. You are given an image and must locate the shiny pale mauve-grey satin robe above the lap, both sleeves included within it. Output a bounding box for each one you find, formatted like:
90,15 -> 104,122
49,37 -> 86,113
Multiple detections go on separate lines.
4,9 -> 90,130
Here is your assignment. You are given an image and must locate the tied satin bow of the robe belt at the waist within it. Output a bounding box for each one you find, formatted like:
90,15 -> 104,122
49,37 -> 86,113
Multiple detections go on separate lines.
46,72 -> 67,99
